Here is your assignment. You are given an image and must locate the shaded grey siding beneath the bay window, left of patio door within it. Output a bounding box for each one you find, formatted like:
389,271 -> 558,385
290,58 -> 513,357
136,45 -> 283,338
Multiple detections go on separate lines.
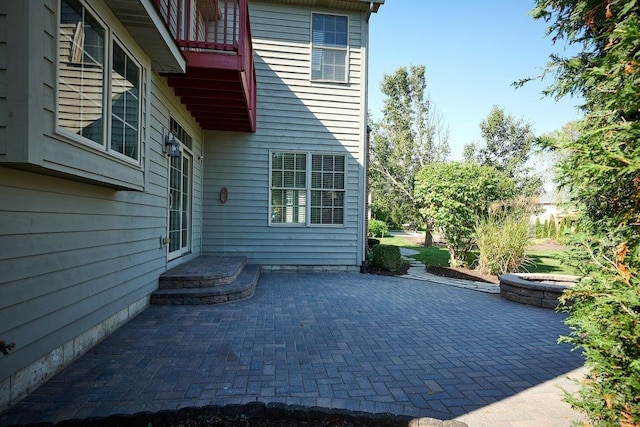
0,167 -> 166,382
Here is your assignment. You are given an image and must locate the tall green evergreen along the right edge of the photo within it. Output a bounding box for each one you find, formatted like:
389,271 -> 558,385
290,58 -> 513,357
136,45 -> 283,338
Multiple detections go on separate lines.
520,0 -> 640,427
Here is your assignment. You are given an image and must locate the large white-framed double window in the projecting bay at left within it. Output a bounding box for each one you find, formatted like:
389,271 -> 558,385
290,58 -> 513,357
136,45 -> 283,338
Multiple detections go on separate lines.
58,0 -> 142,161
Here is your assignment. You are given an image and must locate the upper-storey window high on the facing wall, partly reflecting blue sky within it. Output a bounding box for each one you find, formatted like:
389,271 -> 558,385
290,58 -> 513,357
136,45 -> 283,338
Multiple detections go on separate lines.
311,13 -> 349,83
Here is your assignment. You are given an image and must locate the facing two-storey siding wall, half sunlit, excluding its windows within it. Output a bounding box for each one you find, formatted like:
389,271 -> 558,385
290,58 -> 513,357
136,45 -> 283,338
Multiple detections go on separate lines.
203,1 -> 368,270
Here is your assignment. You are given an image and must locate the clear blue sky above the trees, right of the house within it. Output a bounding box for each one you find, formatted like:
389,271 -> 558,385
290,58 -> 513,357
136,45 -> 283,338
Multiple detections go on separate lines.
369,0 -> 579,159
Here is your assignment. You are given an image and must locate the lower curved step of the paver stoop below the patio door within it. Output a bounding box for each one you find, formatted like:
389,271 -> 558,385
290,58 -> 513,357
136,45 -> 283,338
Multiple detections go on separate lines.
151,264 -> 260,305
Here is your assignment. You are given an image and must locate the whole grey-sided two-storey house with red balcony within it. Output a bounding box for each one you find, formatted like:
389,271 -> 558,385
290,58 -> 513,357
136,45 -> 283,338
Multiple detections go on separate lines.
0,0 -> 384,410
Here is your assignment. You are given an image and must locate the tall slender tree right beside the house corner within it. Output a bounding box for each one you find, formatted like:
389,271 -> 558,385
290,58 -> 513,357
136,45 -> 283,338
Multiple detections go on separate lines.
370,65 -> 449,245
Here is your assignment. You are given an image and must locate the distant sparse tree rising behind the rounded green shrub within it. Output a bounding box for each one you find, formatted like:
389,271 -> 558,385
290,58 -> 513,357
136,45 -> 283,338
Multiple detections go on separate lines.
463,105 -> 542,196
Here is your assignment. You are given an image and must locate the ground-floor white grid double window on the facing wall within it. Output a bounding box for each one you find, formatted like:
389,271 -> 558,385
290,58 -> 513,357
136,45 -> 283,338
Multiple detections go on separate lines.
270,152 -> 346,225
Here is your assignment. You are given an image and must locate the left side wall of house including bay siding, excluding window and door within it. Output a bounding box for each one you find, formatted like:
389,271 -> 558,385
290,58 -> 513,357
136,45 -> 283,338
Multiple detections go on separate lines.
0,0 -> 203,411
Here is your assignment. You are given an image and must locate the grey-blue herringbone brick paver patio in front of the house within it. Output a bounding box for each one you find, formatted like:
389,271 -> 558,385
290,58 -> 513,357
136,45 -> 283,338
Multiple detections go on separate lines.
0,273 -> 583,425
